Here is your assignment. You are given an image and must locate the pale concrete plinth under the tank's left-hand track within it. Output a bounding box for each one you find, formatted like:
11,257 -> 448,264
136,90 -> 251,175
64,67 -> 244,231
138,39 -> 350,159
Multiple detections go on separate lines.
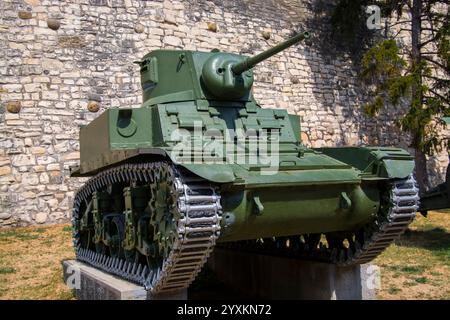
63,260 -> 187,300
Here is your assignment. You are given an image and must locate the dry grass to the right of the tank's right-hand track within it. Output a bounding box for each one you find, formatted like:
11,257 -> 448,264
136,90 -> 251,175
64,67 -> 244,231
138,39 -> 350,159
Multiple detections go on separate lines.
374,212 -> 450,300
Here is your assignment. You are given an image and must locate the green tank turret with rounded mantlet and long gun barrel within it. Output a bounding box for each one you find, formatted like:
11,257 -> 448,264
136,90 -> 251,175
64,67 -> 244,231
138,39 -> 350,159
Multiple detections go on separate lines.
139,32 -> 309,104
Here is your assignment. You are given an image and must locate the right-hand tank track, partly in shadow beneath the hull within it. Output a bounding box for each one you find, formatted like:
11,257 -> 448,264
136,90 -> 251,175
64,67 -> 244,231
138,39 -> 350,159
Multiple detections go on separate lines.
219,175 -> 419,266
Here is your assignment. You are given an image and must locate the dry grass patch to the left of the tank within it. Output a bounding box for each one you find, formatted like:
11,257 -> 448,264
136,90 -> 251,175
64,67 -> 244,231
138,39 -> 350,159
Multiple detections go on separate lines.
0,225 -> 74,299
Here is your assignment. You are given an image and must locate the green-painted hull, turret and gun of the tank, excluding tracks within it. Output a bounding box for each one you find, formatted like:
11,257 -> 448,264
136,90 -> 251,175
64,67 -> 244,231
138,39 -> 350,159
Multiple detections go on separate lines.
73,34 -> 414,240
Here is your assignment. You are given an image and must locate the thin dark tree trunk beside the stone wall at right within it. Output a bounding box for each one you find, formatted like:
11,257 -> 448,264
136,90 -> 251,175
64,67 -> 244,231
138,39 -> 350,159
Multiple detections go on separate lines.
411,0 -> 428,192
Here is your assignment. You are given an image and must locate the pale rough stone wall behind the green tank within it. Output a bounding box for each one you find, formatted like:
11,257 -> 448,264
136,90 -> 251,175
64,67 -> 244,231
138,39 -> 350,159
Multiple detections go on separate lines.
0,0 -> 447,226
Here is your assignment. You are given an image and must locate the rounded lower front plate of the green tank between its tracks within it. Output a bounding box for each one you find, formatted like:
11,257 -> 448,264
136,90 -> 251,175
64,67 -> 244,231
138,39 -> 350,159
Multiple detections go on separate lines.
219,183 -> 379,242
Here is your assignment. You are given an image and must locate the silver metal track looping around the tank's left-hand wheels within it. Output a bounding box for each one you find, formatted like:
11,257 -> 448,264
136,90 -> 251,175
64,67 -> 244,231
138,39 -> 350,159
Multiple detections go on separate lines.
72,162 -> 222,294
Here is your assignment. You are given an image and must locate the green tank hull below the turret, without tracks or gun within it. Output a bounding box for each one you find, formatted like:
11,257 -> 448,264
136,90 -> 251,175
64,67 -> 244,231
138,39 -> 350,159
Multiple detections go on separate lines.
73,102 -> 414,242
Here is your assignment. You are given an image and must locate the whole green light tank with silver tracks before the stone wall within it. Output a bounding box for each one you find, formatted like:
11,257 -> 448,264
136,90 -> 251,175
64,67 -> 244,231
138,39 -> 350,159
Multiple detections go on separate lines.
71,32 -> 419,294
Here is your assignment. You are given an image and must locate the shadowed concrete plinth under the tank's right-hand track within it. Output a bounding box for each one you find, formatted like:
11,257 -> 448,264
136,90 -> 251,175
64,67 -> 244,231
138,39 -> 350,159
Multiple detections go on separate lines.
208,248 -> 379,300
